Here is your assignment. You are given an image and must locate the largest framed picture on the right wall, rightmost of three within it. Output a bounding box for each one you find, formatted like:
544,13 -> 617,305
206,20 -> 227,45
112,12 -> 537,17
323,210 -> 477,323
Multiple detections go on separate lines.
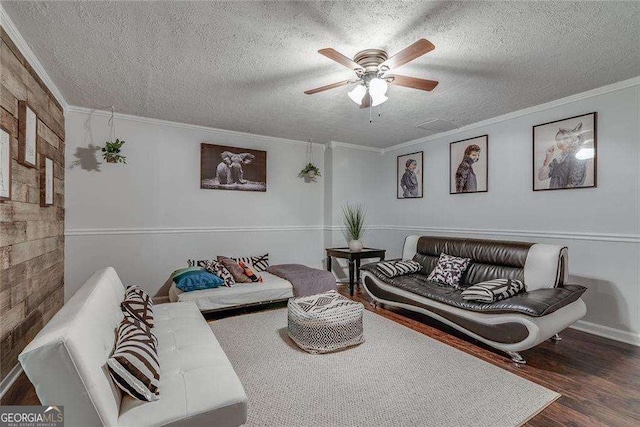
533,113 -> 598,191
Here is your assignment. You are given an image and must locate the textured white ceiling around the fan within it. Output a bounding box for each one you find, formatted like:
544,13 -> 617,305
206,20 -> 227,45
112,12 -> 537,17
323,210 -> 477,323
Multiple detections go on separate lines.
2,1 -> 640,147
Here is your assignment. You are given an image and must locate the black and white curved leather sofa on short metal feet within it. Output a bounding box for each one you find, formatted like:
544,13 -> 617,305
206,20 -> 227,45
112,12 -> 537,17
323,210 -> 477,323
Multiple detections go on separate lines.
362,236 -> 586,363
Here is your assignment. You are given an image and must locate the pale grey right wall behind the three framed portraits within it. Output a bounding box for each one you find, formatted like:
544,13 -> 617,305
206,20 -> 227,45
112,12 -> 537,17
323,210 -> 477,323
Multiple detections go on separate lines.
376,85 -> 640,343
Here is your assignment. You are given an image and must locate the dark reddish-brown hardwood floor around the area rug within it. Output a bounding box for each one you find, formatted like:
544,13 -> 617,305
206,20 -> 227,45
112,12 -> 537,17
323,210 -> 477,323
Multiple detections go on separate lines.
1,286 -> 640,427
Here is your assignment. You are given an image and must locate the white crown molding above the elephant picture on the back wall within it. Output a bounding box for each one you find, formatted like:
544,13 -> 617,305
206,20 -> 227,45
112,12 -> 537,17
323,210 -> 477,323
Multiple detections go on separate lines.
67,105 -> 327,151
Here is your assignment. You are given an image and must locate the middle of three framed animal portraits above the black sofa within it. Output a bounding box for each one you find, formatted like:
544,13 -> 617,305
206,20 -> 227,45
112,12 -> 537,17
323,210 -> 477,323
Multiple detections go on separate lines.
449,135 -> 489,194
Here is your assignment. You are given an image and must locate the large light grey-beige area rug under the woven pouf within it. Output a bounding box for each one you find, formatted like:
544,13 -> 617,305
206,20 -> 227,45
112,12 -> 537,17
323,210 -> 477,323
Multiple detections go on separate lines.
211,309 -> 560,427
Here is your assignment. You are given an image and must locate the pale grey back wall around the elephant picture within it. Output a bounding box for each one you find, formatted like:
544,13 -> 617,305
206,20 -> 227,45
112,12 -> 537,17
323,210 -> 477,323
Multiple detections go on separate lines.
65,108 -> 324,299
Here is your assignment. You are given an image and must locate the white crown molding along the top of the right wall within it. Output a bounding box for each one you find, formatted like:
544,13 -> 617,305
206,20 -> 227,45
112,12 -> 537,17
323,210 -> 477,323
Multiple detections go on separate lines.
382,76 -> 640,154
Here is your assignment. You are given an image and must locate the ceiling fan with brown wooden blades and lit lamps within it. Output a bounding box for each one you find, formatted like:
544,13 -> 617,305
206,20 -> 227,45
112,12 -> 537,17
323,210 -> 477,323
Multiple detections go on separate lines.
305,39 -> 438,108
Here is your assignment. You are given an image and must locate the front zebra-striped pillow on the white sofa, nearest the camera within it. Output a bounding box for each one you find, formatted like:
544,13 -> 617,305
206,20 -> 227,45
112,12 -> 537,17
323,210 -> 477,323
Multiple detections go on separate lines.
107,313 -> 160,402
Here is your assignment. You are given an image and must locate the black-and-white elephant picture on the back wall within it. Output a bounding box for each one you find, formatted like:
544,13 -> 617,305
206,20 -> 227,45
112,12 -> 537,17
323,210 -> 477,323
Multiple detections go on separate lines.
200,143 -> 267,191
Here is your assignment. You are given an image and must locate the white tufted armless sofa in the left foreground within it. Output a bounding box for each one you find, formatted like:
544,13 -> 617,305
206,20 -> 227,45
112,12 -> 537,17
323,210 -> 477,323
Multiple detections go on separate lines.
19,267 -> 247,427
